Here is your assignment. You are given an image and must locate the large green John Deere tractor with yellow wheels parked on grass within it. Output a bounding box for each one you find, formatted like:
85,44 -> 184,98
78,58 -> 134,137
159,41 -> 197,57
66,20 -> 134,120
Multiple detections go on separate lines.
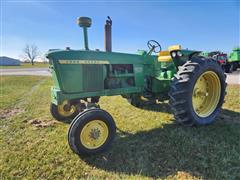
46,17 -> 226,155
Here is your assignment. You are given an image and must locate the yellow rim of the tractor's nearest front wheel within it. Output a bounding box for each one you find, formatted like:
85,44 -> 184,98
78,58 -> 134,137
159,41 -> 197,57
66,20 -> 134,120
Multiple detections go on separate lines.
80,120 -> 109,149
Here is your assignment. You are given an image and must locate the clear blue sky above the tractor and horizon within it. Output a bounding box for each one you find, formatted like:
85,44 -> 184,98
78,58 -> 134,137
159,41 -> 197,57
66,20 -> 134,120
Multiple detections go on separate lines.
1,0 -> 240,58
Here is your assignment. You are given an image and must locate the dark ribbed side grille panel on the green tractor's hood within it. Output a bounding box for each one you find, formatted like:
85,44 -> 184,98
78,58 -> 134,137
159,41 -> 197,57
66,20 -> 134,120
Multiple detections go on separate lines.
83,64 -> 104,92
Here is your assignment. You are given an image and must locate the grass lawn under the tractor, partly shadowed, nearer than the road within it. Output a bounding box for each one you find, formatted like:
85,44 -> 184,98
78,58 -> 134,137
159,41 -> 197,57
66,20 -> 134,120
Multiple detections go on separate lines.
0,76 -> 240,179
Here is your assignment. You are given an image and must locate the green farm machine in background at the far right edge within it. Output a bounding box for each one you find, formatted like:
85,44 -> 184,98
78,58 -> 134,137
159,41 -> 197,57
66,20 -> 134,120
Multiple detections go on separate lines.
225,48 -> 240,73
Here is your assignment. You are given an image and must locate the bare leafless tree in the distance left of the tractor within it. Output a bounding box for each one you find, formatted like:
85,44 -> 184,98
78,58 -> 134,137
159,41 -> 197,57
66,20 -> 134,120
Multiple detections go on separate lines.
23,44 -> 40,65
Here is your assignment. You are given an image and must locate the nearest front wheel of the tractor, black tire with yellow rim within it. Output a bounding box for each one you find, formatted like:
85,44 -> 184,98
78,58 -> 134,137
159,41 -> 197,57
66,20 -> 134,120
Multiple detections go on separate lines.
68,108 -> 116,155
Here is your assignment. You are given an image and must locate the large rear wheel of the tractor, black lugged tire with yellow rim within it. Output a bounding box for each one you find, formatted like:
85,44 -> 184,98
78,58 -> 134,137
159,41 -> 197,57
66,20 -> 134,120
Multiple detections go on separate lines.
169,57 -> 226,126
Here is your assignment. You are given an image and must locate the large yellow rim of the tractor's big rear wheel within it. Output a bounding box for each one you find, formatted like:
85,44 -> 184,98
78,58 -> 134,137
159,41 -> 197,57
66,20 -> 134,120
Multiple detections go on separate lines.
192,71 -> 221,117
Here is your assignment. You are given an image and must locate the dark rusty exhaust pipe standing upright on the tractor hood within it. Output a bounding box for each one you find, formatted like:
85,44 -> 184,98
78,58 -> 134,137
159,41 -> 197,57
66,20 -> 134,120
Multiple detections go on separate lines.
104,16 -> 112,52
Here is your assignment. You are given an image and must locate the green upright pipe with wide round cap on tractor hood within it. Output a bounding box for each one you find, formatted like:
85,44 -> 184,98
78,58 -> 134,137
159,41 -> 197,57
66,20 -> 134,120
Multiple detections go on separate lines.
77,17 -> 92,50
